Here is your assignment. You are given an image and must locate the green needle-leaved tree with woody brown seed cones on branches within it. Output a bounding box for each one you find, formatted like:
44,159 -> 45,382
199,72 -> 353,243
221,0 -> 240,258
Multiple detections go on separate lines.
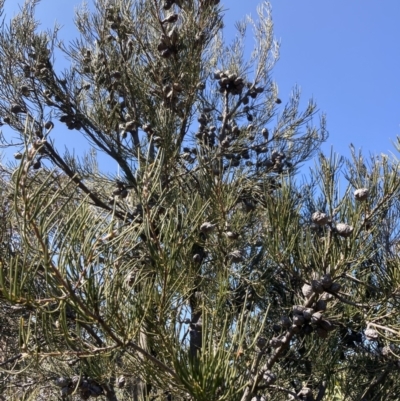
0,0 -> 400,401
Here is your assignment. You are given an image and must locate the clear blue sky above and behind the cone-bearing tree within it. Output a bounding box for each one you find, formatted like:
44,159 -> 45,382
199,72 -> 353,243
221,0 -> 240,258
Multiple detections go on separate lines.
5,0 -> 400,170
